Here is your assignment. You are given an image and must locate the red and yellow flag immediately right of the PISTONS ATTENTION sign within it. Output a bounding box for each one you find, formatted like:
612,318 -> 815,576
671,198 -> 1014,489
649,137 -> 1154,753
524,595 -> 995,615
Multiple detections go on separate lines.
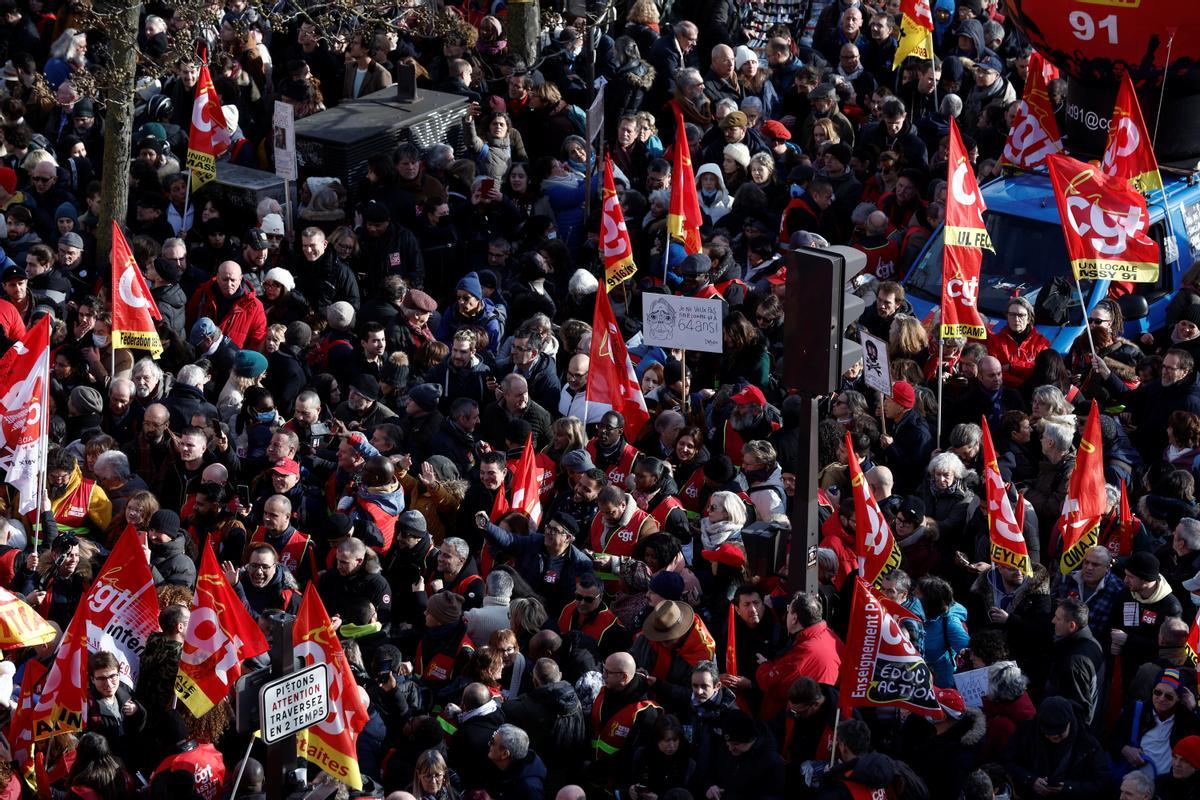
293,582 -> 367,789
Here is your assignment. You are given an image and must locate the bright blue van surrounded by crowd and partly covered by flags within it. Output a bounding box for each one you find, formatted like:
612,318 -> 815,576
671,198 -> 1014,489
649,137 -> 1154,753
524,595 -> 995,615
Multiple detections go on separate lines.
904,173 -> 1200,354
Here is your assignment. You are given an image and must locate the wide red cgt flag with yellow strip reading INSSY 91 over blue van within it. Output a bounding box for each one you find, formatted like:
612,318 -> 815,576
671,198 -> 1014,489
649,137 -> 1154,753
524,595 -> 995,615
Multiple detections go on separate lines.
1046,155 -> 1159,283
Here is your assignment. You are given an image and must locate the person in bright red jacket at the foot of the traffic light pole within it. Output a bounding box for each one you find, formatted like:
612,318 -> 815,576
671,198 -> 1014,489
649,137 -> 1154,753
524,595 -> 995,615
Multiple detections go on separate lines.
755,595 -> 841,720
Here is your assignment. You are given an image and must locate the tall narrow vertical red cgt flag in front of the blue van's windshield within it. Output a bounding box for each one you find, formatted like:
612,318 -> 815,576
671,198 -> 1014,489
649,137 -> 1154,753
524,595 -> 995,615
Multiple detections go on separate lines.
942,120 -> 995,339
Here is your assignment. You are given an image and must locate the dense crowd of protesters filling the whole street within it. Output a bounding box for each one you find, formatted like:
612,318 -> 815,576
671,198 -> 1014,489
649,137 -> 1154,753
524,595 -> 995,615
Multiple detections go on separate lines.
0,0 -> 1200,800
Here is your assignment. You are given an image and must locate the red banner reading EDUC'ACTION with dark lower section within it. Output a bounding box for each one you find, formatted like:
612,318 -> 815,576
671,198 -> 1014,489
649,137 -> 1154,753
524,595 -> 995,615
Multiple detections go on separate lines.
838,578 -> 943,720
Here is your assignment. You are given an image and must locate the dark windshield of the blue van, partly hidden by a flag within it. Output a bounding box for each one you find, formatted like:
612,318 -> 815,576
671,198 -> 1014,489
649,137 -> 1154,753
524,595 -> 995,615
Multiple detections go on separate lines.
905,211 -> 1090,323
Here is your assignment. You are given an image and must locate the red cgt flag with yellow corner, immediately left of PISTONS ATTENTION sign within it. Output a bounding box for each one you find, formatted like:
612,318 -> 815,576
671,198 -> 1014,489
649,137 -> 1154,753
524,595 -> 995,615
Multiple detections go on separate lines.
175,542 -> 266,717
